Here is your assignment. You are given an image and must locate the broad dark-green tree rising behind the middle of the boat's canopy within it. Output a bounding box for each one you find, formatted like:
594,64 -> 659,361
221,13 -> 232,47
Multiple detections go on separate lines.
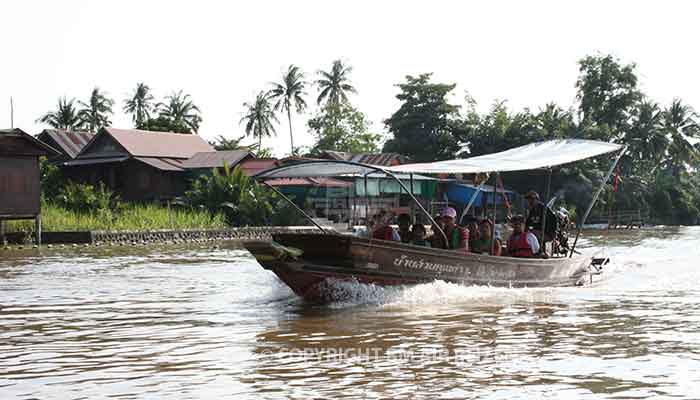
384,74 -> 464,162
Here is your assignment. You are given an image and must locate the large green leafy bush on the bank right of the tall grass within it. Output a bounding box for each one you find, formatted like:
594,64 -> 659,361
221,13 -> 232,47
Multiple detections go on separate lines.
186,164 -> 298,226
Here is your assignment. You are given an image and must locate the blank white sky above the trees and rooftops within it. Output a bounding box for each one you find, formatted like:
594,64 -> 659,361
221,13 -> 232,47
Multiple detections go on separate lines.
0,0 -> 700,155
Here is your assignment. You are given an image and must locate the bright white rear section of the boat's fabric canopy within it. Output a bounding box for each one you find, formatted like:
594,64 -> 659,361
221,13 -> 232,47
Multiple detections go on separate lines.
385,139 -> 623,174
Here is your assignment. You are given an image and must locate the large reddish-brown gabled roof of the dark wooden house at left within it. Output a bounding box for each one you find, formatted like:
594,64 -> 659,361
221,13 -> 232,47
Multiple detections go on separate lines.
90,128 -> 214,158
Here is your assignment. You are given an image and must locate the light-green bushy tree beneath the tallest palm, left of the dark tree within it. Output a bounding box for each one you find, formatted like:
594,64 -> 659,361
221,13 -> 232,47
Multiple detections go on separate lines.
308,102 -> 381,154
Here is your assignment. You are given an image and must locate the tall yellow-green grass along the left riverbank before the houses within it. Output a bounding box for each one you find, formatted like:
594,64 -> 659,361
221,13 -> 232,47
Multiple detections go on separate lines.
7,202 -> 227,233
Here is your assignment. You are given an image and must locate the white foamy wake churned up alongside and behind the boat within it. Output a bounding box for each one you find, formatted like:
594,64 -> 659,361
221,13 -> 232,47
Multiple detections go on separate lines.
325,228 -> 700,309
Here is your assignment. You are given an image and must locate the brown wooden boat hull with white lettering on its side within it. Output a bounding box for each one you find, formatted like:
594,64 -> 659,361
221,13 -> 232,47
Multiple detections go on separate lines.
244,233 -> 591,302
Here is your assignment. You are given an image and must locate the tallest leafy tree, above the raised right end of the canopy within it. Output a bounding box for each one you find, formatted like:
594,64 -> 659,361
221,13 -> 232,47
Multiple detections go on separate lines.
576,55 -> 642,140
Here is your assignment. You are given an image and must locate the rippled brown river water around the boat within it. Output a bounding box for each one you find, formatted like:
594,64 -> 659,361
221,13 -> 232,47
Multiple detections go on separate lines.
0,228 -> 700,400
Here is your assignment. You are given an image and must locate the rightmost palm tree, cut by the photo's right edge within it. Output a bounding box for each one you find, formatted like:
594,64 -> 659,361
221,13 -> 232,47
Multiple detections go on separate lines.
663,99 -> 700,177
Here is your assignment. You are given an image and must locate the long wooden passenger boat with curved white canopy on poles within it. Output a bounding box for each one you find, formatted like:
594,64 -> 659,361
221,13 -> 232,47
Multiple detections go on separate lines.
244,139 -> 625,302
